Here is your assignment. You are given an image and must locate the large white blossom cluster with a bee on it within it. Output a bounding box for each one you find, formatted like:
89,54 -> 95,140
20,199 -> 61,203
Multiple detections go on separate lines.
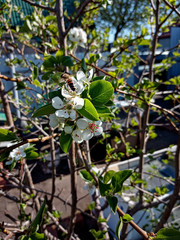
49,70 -> 103,143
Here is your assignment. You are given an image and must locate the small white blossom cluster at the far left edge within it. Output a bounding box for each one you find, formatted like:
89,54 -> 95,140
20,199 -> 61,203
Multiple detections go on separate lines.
6,143 -> 30,165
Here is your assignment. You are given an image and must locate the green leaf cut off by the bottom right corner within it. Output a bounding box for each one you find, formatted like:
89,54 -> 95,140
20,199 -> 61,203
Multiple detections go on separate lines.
154,228 -> 180,240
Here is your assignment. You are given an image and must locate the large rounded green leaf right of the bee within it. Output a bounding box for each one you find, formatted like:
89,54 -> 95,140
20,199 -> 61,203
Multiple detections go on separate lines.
89,80 -> 114,106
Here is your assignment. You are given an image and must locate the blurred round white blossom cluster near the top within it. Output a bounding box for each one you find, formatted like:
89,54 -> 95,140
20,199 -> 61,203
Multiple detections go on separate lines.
69,27 -> 87,45
